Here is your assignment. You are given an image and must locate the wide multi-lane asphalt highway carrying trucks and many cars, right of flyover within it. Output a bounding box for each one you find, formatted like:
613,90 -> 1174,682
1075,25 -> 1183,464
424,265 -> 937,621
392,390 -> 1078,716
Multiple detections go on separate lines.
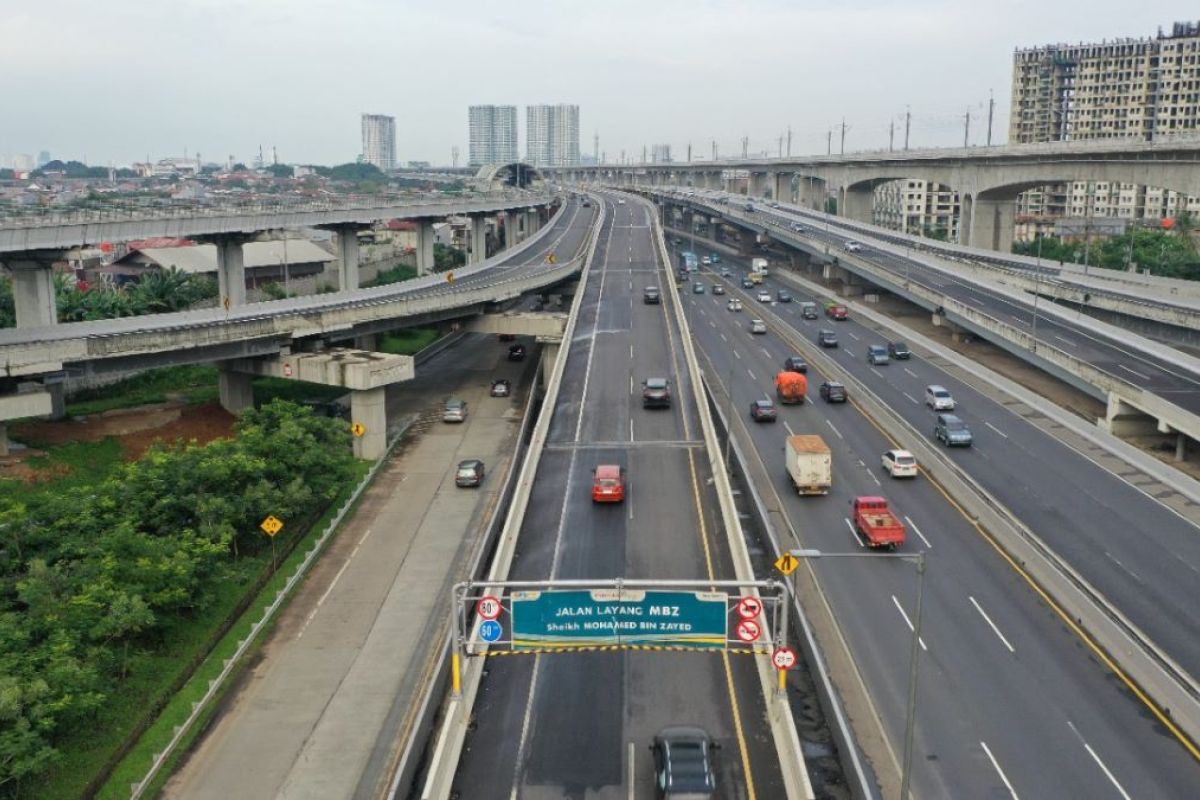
683,247 -> 1200,798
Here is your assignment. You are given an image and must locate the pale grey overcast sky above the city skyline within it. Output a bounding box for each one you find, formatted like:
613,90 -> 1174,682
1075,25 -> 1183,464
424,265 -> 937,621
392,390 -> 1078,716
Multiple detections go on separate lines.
0,0 -> 1200,166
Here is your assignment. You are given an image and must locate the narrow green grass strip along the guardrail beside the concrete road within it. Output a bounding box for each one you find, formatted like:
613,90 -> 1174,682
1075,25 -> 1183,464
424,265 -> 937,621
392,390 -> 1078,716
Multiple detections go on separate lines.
94,462 -> 371,800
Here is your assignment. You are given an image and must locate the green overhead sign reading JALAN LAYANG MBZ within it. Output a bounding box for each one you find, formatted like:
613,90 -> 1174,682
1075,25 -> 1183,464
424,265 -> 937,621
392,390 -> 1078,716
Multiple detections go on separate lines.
511,589 -> 728,649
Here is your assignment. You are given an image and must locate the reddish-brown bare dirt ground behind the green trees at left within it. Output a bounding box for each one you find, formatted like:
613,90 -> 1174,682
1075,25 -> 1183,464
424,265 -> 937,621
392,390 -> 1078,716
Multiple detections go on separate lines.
0,403 -> 234,482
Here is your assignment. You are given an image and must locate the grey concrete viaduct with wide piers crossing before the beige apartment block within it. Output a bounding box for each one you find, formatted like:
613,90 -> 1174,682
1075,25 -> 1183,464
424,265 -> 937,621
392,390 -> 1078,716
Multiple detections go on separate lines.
557,140 -> 1200,252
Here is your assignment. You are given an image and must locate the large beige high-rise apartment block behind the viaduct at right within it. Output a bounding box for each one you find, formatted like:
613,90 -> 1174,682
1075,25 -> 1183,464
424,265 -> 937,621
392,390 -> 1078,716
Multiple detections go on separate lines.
1008,22 -> 1200,237
